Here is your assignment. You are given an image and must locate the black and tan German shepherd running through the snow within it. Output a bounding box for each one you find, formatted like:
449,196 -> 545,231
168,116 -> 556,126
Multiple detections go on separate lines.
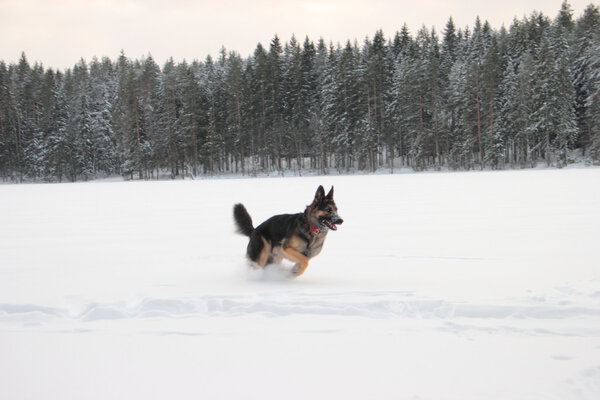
233,186 -> 344,277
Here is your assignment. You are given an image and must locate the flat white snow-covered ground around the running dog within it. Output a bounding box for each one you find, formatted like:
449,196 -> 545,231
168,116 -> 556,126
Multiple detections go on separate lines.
0,168 -> 600,400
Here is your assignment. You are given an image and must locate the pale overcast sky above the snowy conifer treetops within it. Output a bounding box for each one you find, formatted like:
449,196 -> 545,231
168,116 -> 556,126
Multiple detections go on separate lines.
0,0 -> 598,69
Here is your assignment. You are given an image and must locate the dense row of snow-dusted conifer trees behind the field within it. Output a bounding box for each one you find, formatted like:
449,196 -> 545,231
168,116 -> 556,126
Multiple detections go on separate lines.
0,2 -> 600,181
